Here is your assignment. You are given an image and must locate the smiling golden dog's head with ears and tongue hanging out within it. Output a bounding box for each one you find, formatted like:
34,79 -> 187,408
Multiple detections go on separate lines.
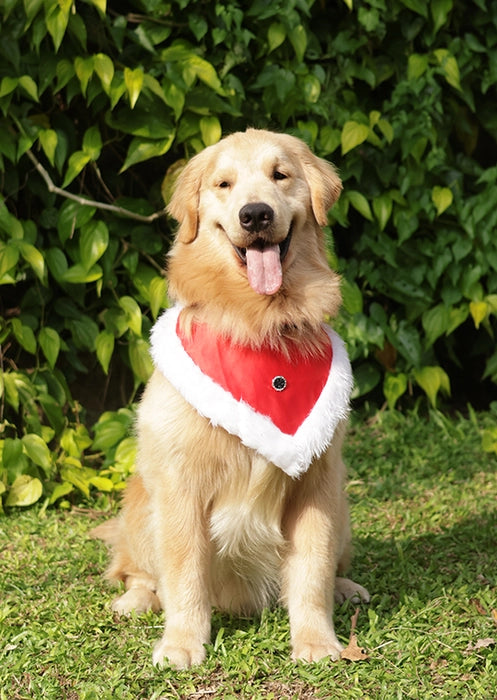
168,129 -> 341,295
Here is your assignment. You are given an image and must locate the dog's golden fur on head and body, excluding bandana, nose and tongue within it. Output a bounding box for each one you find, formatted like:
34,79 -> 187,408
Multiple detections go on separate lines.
96,129 -> 368,668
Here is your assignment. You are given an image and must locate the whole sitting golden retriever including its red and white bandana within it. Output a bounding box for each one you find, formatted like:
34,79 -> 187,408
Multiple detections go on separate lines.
95,129 -> 369,668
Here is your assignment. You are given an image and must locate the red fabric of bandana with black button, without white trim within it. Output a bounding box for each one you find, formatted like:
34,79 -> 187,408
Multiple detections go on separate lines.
176,319 -> 333,435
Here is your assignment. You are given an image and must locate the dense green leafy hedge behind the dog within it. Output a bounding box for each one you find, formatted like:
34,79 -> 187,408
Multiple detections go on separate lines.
0,0 -> 497,506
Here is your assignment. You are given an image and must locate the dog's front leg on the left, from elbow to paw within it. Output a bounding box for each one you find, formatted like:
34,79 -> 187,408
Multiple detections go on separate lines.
149,487 -> 211,668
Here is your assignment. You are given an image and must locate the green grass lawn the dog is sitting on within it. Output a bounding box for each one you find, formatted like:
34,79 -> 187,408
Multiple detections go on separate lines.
0,413 -> 497,700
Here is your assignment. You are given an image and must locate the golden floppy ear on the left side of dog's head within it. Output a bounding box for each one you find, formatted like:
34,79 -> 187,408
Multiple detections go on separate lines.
166,152 -> 203,243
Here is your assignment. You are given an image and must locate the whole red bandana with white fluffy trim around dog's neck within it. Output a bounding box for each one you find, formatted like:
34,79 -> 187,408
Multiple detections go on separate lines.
151,307 -> 352,477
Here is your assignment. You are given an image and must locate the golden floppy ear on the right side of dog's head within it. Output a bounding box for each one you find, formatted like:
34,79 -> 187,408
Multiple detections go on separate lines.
302,151 -> 342,226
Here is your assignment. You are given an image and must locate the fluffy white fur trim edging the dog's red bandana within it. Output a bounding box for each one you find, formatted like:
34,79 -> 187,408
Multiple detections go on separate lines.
151,306 -> 353,477
